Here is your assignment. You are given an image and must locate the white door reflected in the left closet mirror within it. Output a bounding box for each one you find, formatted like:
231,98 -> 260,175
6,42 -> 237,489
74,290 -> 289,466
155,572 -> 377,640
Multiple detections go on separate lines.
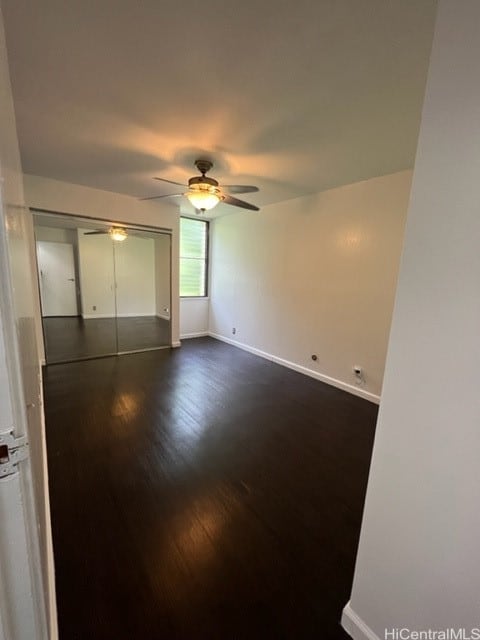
37,241 -> 78,316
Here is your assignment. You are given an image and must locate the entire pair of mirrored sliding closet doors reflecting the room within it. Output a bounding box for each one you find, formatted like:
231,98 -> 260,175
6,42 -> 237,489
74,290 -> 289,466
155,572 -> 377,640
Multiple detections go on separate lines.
34,214 -> 171,363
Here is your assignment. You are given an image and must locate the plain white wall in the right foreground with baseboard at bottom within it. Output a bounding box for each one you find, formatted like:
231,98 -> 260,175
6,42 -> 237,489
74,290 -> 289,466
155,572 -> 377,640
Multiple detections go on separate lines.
344,0 -> 480,638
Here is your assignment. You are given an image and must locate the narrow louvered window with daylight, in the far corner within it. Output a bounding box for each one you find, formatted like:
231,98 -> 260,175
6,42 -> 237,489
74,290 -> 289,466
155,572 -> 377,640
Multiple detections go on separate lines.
180,218 -> 208,298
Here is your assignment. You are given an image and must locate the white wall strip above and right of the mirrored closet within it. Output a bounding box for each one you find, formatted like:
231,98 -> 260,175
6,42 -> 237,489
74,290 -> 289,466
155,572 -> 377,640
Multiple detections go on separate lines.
24,175 -> 179,346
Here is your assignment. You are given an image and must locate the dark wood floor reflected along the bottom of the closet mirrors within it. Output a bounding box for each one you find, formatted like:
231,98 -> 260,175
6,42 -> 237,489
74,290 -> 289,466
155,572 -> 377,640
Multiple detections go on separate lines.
43,316 -> 171,364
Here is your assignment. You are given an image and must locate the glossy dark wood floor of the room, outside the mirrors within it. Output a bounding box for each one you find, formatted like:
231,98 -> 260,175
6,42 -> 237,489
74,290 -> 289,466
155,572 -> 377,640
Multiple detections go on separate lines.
45,338 -> 377,640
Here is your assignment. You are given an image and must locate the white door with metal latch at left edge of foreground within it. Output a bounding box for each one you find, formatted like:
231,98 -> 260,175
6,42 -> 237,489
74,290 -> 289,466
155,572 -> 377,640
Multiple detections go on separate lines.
0,198 -> 51,640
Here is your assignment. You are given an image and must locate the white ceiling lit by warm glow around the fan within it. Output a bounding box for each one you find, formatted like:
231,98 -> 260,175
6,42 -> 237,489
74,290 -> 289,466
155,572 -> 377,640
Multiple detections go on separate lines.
2,0 -> 436,218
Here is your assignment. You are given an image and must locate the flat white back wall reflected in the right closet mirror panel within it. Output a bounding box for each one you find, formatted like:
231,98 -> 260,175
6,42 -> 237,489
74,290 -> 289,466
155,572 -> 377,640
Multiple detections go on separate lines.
115,234 -> 156,317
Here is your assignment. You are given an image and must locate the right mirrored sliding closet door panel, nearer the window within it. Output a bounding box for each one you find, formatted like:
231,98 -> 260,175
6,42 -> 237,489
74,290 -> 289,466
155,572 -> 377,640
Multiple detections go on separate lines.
114,229 -> 171,353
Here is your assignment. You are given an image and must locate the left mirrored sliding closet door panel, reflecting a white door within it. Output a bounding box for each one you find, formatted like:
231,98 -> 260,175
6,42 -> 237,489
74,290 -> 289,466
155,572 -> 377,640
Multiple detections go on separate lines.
34,215 -> 117,364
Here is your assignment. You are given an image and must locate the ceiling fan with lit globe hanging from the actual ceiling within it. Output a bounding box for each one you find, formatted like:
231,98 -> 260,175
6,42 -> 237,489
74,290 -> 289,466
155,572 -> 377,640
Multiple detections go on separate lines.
140,159 -> 259,213
